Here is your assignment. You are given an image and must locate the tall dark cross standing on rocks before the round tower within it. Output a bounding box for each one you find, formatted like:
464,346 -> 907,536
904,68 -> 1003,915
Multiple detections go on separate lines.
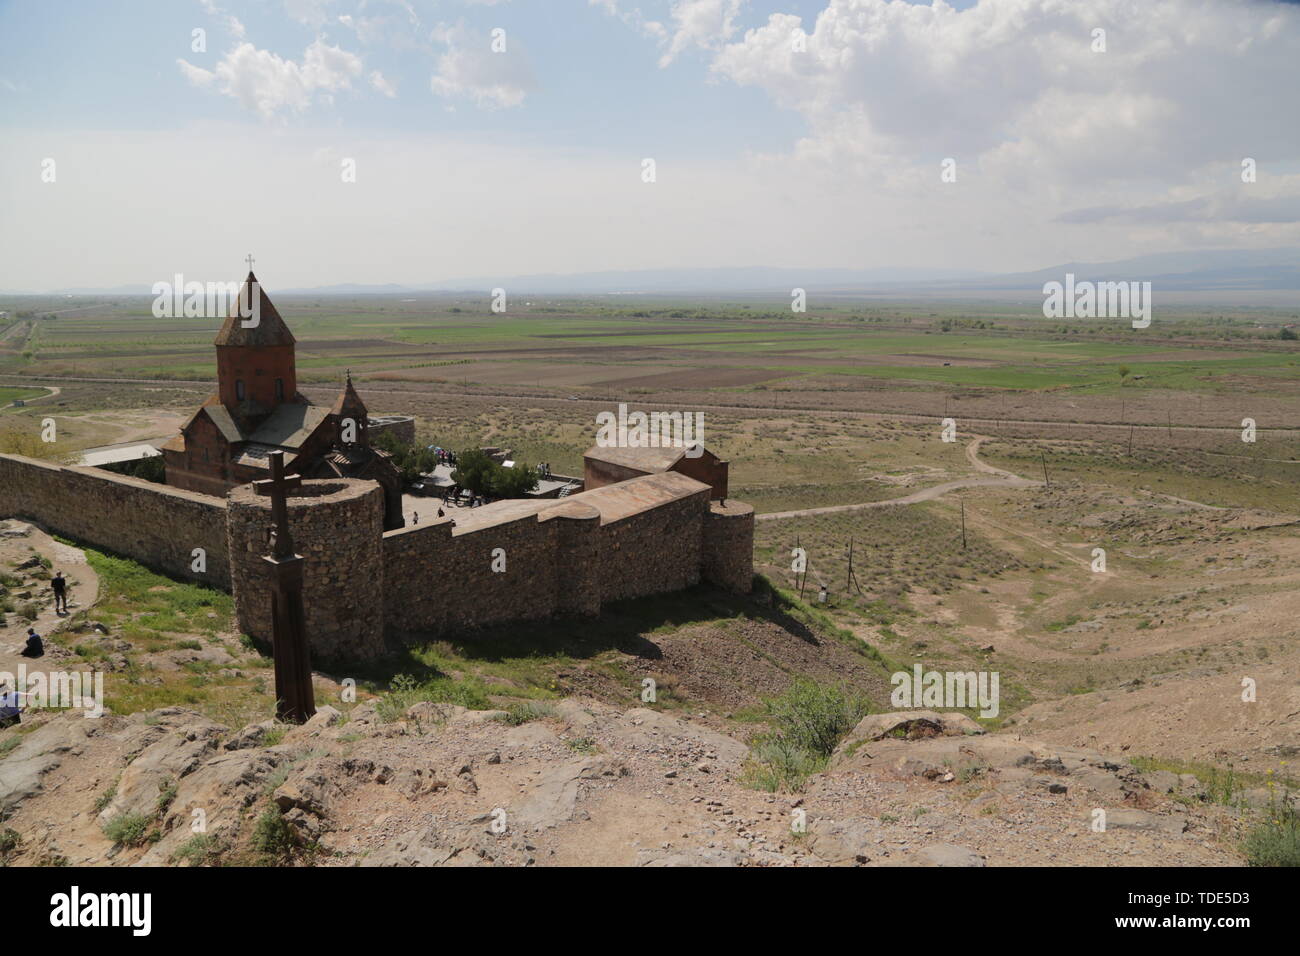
254,451 -> 316,723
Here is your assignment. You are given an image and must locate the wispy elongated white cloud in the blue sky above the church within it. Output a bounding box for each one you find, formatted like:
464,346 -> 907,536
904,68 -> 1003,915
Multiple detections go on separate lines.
177,39 -> 361,118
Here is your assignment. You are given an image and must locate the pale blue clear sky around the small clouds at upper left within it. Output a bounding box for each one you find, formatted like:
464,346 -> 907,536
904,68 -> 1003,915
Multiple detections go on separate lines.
0,0 -> 847,152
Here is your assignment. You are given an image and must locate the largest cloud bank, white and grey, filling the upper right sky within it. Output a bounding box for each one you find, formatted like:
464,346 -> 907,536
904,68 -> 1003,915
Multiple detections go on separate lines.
711,0 -> 1300,252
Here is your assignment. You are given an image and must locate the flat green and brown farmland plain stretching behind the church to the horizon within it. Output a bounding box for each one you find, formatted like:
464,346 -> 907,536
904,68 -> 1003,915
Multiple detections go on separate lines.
0,290 -> 1300,397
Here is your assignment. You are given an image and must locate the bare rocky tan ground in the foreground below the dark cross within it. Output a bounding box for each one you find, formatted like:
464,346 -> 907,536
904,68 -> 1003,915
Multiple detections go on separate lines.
0,698 -> 1258,866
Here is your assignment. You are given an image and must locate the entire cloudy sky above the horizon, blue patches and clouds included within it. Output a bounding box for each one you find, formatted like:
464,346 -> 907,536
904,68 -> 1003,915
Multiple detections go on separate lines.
0,0 -> 1300,291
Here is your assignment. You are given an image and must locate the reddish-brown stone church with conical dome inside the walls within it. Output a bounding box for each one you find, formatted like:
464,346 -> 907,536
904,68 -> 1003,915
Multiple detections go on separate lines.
163,271 -> 403,531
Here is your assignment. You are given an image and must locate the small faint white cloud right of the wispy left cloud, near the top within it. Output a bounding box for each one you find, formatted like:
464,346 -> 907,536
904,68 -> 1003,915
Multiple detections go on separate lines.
429,23 -> 537,109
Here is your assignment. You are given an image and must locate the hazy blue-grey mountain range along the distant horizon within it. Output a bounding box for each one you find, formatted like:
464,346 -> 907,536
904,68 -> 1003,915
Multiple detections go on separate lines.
3,247 -> 1300,298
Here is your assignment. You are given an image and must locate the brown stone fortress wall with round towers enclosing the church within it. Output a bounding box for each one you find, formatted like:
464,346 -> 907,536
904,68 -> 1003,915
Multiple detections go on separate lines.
0,455 -> 754,662
